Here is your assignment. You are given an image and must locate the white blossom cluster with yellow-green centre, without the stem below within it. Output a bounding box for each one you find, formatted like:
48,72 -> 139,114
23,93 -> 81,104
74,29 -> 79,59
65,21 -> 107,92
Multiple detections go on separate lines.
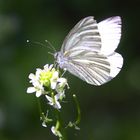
27,64 -> 69,109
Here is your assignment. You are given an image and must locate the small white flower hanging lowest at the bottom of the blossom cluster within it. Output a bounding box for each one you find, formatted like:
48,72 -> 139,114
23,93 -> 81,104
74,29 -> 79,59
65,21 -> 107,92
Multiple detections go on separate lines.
45,94 -> 61,109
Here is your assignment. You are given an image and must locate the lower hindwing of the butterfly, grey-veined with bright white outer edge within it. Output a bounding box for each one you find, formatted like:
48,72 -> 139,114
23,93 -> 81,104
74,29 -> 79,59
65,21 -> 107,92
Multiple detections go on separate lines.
60,52 -> 123,85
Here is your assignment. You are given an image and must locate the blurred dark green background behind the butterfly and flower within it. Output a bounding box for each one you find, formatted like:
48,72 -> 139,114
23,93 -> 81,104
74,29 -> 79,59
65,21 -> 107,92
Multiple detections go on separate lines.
0,0 -> 140,140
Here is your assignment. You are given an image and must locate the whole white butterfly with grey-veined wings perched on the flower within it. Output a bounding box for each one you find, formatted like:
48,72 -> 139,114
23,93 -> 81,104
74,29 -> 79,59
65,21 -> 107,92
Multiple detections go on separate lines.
54,16 -> 123,85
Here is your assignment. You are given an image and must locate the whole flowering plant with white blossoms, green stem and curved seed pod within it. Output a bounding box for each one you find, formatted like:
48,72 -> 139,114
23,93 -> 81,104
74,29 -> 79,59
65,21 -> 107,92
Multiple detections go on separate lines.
27,64 -> 80,140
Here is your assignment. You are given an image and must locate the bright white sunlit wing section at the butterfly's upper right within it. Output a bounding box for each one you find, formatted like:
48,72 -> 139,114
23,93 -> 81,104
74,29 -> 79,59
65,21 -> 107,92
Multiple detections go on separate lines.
98,16 -> 121,55
